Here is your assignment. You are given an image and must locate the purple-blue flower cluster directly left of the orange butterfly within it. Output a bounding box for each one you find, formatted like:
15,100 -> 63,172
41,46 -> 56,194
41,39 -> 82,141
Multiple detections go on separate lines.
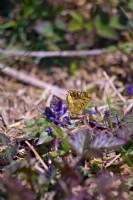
43,96 -> 69,127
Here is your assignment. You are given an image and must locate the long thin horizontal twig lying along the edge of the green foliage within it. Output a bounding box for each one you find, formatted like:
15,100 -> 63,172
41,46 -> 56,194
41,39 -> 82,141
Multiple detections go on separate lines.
0,49 -> 106,58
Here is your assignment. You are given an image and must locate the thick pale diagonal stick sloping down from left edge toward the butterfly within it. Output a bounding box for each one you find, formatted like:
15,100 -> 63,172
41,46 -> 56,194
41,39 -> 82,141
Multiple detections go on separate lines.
0,63 -> 66,99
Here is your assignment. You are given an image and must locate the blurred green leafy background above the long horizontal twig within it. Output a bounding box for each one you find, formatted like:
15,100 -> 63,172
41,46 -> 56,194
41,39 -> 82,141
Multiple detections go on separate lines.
0,0 -> 133,61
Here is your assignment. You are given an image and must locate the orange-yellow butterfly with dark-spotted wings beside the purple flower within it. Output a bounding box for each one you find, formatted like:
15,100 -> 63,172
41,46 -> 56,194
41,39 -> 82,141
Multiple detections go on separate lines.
67,90 -> 91,114
